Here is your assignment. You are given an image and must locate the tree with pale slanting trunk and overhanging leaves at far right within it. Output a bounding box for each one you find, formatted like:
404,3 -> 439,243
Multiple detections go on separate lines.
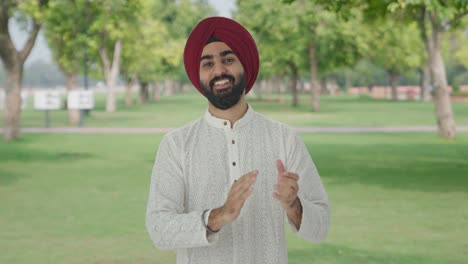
308,0 -> 468,139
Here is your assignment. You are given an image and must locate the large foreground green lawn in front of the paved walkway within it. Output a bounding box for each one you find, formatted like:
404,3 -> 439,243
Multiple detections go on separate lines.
0,134 -> 468,264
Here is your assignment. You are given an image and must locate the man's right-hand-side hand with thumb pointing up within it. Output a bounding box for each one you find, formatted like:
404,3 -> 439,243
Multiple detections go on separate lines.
273,160 -> 300,211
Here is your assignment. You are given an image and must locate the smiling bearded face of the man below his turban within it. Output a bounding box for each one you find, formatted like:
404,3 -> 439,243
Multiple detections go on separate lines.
200,42 -> 246,110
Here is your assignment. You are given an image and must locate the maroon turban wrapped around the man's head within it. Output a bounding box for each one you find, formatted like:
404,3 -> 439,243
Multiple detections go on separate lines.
184,17 -> 260,94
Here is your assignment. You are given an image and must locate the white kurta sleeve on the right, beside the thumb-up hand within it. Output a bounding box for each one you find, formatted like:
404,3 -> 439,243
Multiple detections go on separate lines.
286,129 -> 330,243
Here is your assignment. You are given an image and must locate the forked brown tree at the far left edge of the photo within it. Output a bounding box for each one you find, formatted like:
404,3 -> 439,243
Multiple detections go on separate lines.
0,0 -> 48,140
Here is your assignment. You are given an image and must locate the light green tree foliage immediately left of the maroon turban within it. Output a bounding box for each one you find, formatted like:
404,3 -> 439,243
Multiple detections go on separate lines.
123,0 -> 213,82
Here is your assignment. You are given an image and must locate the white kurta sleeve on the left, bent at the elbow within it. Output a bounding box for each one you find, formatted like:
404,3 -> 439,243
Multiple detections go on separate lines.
146,136 -> 217,250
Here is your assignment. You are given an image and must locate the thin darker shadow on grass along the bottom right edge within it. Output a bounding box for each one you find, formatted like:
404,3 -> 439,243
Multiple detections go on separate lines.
288,244 -> 462,264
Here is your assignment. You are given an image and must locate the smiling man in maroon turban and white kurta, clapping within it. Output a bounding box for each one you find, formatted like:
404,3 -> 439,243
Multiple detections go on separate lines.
146,17 -> 330,264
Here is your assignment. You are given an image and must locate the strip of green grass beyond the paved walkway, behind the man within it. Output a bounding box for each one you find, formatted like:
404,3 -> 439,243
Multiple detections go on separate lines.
12,92 -> 468,127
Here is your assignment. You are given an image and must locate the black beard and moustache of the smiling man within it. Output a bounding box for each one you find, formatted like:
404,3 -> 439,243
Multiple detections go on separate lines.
200,74 -> 246,110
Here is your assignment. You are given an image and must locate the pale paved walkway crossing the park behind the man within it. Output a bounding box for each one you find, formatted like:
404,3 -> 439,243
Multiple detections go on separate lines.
0,126 -> 468,134
